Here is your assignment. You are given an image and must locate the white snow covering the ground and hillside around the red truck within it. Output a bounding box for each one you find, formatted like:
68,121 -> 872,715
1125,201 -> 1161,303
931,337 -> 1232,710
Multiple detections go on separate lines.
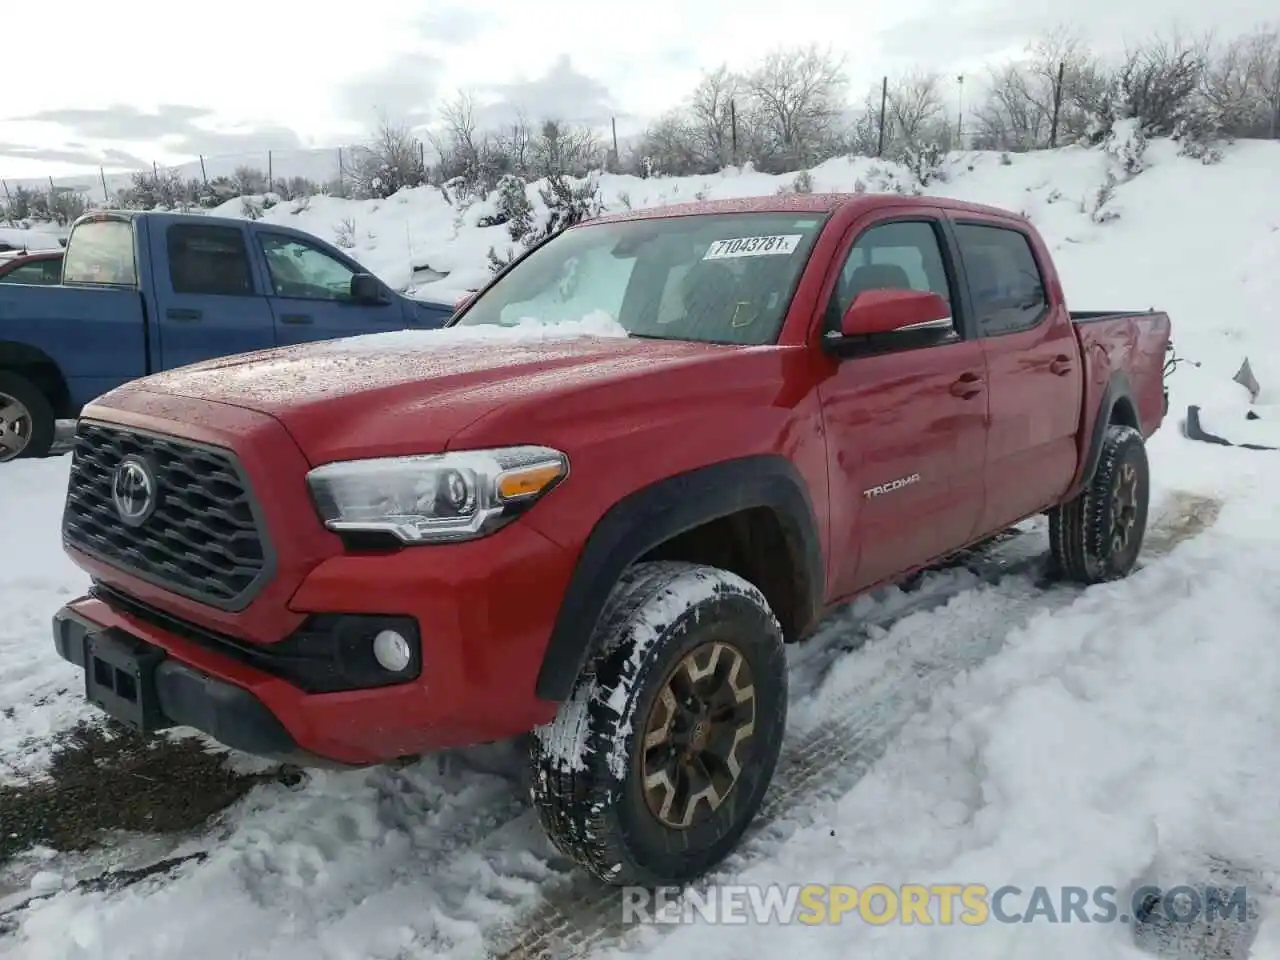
0,136 -> 1280,960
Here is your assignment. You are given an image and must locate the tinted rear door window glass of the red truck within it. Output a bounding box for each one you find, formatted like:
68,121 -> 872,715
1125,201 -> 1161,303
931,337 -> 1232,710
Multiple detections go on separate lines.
955,223 -> 1048,337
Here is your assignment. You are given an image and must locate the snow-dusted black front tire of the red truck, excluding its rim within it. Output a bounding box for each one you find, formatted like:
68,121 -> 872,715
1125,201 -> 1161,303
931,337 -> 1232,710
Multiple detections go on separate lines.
530,562 -> 787,886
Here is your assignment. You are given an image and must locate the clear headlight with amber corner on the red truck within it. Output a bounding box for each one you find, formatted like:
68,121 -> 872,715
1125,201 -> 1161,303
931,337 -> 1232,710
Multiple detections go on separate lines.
307,447 -> 568,544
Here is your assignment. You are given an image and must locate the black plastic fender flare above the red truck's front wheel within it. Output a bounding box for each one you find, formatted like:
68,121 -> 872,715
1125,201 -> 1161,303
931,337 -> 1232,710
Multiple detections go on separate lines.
535,454 -> 826,703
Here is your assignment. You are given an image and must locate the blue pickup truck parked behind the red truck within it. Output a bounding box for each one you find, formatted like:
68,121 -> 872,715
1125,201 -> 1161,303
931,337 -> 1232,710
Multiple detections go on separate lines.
0,210 -> 454,462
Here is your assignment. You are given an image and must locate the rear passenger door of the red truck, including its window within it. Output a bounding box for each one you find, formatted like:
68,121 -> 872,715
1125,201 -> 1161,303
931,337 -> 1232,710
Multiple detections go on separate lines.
952,214 -> 1082,532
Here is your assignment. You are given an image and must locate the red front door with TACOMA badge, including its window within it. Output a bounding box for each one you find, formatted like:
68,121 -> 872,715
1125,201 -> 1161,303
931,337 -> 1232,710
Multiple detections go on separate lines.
819,209 -> 987,596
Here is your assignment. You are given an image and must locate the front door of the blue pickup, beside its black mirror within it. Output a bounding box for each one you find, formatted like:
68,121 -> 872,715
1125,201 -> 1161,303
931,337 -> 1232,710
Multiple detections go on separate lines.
255,228 -> 408,347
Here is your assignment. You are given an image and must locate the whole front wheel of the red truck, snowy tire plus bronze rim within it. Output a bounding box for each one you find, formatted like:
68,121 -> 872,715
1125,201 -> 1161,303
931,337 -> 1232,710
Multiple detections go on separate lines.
531,562 -> 787,886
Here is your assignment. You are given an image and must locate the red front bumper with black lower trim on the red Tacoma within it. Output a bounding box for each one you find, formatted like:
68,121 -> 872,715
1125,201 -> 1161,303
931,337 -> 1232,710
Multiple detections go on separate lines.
54,514 -> 575,767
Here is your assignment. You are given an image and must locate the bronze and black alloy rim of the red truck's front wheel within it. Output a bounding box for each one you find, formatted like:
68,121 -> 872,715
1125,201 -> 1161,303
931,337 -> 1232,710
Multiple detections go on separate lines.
637,640 -> 755,829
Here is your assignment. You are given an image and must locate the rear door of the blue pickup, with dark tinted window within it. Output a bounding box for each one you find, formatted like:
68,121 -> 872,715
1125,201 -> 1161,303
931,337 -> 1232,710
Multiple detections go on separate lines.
148,218 -> 275,370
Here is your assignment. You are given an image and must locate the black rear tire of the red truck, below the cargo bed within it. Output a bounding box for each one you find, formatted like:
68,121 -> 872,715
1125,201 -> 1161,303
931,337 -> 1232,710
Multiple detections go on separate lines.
1048,424 -> 1151,584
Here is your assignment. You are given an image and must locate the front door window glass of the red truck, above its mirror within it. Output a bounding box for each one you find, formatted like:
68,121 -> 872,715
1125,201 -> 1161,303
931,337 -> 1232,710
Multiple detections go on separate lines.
826,220 -> 955,330
